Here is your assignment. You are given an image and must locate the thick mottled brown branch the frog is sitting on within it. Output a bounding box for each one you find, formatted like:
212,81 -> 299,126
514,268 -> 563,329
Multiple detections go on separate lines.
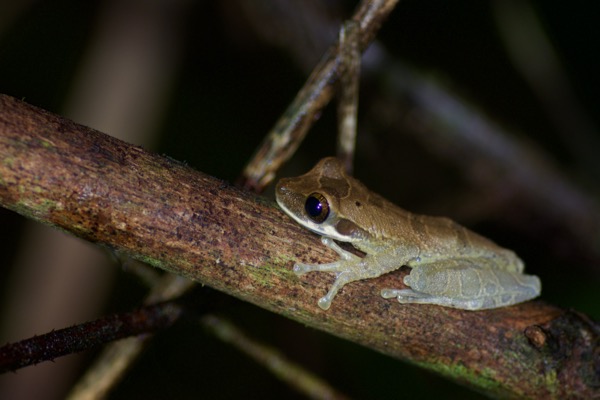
0,96 -> 600,398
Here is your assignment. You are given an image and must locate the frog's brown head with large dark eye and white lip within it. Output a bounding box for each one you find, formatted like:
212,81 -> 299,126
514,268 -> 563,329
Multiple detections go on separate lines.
275,157 -> 370,242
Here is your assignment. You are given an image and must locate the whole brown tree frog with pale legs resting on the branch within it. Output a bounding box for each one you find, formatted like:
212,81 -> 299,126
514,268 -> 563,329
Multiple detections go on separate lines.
275,157 -> 541,311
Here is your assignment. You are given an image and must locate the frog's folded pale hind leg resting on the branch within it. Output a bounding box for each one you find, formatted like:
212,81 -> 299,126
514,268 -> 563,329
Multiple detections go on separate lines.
381,260 -> 541,310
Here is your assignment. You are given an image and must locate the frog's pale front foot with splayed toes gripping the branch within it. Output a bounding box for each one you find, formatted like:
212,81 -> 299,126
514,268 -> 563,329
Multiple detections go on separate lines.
294,237 -> 362,310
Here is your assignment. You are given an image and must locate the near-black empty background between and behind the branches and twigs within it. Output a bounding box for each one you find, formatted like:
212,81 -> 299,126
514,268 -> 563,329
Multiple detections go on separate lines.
0,0 -> 600,399
